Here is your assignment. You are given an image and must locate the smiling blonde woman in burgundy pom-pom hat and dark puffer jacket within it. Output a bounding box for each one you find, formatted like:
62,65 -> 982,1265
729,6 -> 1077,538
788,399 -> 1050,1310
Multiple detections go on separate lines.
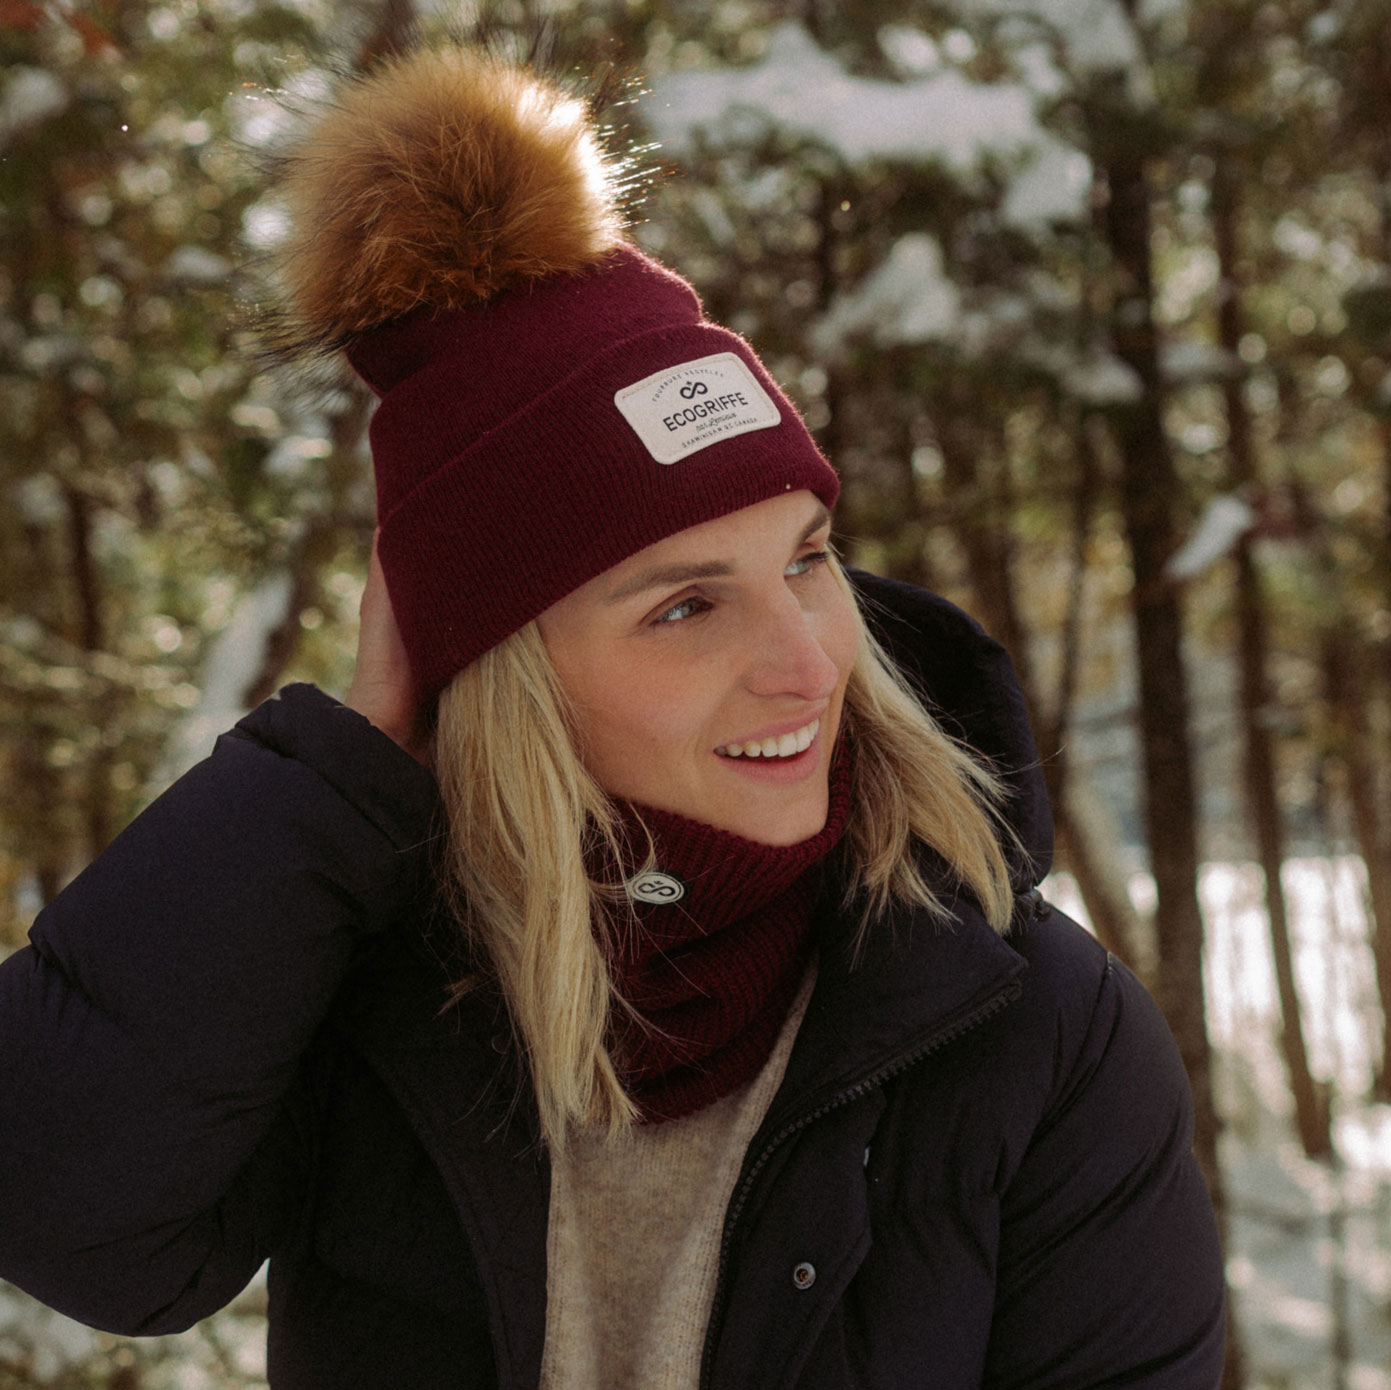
0,38 -> 1223,1390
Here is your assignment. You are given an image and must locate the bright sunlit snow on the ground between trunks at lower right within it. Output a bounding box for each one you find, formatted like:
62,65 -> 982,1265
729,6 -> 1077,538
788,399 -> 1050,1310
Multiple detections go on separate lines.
1047,857 -> 1391,1390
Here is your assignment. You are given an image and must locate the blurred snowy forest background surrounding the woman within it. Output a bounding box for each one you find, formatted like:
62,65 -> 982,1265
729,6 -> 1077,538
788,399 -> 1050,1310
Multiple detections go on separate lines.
0,0 -> 1391,1390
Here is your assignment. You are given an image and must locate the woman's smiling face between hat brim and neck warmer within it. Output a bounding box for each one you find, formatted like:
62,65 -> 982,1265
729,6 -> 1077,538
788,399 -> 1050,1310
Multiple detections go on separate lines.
538,493 -> 858,845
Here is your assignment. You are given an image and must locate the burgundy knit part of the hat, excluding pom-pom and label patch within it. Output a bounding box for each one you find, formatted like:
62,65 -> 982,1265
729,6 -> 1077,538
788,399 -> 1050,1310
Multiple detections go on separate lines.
348,245 -> 839,697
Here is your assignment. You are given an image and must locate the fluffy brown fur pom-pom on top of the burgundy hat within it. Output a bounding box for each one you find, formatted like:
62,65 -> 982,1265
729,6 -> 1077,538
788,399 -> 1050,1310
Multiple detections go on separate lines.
271,47 -> 622,355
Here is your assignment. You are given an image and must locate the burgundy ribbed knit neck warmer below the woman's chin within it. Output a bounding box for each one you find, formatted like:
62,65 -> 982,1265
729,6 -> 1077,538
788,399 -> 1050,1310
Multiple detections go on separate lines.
611,744 -> 850,1123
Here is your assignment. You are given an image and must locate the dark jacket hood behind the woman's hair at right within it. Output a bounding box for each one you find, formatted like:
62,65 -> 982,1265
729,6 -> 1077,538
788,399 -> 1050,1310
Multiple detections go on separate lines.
850,569 -> 1053,893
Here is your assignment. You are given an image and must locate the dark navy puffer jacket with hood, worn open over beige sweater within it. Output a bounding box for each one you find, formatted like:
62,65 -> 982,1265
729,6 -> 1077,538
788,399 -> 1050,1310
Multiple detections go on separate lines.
0,577 -> 1223,1390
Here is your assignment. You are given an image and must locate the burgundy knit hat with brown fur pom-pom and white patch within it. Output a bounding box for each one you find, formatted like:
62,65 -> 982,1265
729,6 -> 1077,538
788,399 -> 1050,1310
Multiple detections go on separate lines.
268,46 -> 839,698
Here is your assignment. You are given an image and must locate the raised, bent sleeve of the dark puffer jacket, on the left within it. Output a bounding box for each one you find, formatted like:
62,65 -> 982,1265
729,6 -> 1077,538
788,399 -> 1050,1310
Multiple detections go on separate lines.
0,686 -> 435,1334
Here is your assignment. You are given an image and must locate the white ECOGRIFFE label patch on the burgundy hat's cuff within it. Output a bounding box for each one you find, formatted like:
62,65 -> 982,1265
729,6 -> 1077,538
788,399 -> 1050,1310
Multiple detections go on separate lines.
613,352 -> 782,463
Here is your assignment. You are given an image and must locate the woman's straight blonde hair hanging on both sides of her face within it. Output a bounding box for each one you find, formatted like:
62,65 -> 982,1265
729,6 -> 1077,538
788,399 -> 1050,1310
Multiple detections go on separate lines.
435,566 -> 1013,1148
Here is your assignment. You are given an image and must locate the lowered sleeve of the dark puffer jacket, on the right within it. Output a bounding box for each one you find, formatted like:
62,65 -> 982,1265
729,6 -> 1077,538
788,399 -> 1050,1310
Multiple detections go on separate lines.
985,914 -> 1224,1390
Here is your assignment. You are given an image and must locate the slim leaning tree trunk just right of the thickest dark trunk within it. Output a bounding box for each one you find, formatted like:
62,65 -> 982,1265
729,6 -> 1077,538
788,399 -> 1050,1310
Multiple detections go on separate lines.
1212,150 -> 1333,1159
